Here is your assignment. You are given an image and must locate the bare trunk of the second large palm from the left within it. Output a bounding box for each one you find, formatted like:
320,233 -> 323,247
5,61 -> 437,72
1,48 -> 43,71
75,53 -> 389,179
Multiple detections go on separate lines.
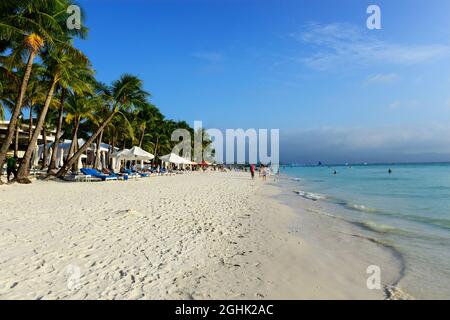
17,75 -> 57,183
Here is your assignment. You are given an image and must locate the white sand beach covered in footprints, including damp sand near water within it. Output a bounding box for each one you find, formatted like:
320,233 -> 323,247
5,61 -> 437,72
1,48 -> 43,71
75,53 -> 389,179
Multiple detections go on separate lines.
0,172 -> 400,299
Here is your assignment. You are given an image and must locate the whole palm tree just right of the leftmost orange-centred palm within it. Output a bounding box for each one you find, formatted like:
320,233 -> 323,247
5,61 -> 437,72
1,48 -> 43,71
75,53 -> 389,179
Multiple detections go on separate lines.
17,44 -> 89,183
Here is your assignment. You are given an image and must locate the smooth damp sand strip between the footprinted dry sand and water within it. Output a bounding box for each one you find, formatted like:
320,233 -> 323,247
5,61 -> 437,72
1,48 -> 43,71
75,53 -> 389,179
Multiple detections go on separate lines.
258,176 -> 412,299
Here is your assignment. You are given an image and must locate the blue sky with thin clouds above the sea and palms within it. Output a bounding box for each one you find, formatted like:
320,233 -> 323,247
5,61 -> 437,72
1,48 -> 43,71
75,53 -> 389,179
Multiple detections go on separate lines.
77,0 -> 450,162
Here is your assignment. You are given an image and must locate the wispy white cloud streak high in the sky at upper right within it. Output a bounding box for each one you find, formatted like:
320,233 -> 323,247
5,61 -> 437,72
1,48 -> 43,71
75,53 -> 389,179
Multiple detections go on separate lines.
292,23 -> 450,70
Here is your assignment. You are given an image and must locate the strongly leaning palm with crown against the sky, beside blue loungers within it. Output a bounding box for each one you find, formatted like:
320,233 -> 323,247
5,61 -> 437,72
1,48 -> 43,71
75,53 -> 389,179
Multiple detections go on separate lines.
56,74 -> 149,178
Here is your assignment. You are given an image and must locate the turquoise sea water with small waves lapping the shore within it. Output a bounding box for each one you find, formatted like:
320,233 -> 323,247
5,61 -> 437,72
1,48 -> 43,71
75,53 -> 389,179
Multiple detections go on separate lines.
281,164 -> 450,299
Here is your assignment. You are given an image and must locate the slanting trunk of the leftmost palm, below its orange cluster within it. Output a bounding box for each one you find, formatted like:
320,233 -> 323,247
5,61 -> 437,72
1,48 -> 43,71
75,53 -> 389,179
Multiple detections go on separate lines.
0,50 -> 37,183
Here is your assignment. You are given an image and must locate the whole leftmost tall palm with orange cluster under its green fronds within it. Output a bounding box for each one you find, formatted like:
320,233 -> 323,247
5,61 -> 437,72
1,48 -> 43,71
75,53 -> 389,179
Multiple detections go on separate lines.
0,0 -> 87,182
